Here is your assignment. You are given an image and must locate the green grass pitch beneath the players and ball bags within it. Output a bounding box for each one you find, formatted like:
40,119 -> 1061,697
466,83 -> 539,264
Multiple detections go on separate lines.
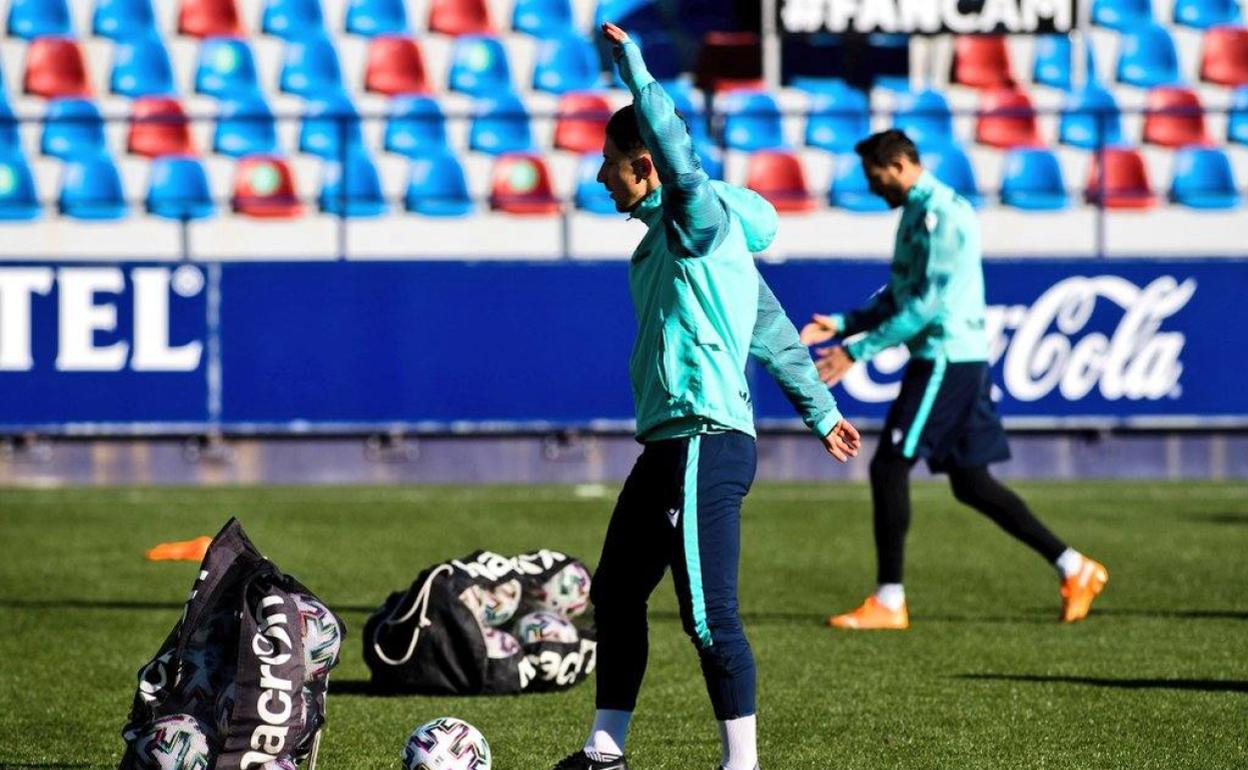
0,483 -> 1248,770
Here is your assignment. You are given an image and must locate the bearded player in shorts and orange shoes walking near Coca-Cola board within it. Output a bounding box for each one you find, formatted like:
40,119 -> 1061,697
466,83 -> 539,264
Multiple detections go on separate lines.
801,130 -> 1109,629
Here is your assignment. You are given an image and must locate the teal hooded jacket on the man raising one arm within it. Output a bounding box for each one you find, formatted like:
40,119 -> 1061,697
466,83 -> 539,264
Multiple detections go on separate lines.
615,41 -> 841,441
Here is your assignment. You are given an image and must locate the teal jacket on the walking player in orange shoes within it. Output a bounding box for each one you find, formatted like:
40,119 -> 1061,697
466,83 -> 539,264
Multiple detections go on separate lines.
834,171 -> 988,363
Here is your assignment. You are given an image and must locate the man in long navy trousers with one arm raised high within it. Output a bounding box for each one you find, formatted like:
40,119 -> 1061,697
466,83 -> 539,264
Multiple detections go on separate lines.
555,24 -> 860,770
